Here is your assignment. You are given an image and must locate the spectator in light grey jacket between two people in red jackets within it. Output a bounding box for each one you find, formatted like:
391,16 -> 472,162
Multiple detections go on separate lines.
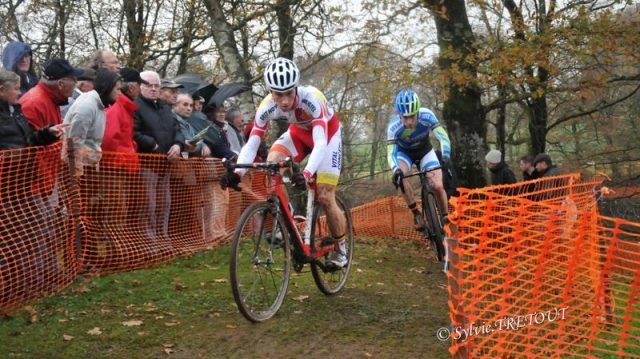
64,69 -> 121,176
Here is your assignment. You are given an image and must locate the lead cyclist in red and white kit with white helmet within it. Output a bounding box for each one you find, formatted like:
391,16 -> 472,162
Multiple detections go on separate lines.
220,57 -> 347,267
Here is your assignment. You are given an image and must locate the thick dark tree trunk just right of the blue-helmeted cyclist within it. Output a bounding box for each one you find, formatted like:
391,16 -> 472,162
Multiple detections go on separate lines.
424,0 -> 487,187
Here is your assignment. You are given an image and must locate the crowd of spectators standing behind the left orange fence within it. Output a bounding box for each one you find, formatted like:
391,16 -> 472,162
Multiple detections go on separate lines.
0,41 -> 260,298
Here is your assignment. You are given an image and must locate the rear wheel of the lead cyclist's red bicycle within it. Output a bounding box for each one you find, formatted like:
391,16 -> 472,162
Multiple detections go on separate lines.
311,195 -> 353,295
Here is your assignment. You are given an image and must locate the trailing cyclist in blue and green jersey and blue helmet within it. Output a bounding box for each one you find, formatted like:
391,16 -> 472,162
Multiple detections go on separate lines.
387,90 -> 451,230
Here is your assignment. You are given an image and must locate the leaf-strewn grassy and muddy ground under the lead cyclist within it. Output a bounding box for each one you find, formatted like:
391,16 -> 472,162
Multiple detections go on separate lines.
0,240 -> 449,358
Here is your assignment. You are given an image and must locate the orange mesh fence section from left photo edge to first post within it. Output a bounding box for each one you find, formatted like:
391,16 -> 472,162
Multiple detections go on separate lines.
0,144 -> 77,310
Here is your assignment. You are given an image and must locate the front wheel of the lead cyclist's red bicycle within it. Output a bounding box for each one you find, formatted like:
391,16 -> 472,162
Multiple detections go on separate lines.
230,201 -> 291,322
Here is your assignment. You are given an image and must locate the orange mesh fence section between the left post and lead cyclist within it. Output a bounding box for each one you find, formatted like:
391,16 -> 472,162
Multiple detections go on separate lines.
78,152 -> 266,273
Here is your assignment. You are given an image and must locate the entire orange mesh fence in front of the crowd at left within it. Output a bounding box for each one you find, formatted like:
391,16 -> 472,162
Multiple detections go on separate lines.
0,144 -> 266,313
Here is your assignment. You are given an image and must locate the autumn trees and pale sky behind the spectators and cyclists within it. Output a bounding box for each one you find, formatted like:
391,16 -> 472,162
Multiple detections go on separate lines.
0,0 -> 640,194
